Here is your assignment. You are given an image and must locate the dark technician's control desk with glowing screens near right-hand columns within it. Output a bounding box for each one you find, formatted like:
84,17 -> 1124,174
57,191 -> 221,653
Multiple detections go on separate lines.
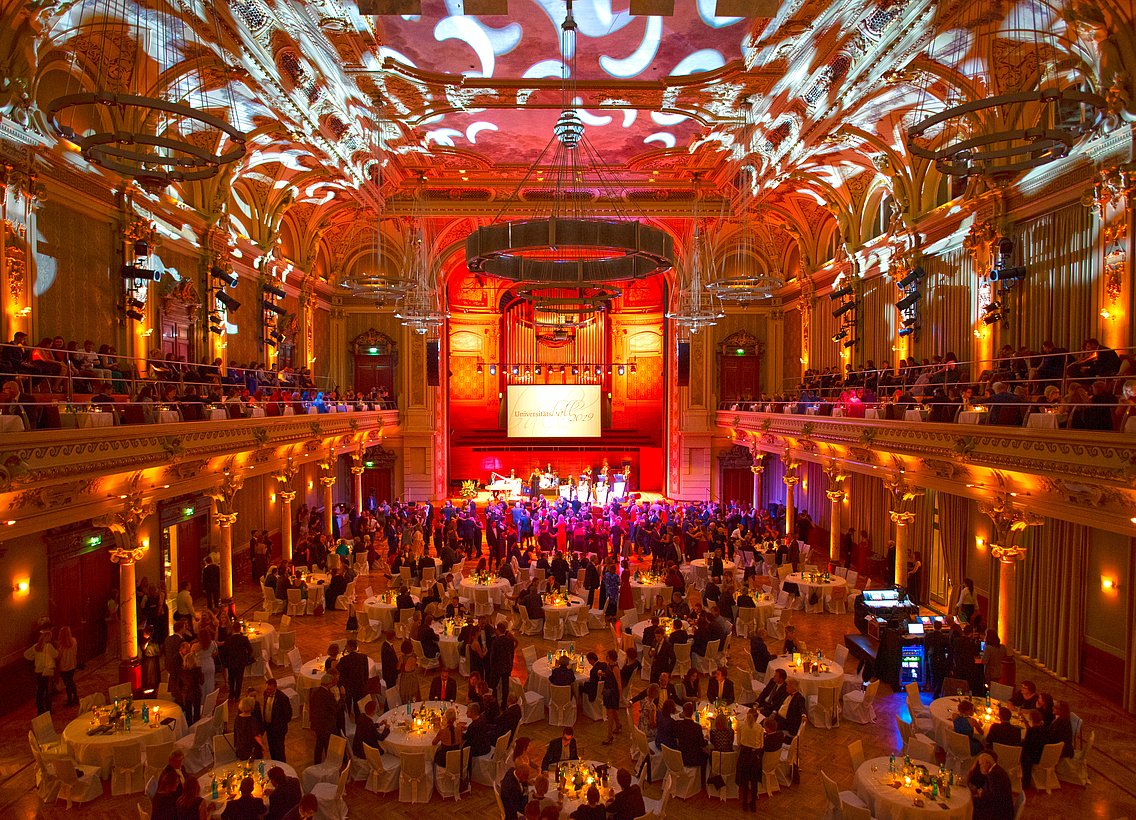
844,586 -> 943,689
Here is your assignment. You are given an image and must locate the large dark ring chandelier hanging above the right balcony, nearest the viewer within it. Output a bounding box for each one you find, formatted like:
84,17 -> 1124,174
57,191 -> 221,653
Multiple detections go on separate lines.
904,2 -> 1106,177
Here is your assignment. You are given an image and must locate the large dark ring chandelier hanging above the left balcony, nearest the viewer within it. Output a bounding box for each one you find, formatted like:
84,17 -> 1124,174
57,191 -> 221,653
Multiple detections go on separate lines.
45,0 -> 245,190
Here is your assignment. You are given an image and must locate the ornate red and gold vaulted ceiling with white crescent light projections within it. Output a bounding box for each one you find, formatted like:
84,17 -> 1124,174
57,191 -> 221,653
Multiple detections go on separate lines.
0,0 -> 1136,287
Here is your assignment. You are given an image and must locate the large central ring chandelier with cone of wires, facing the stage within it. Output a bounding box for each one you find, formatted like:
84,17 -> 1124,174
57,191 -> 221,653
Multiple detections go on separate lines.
466,0 -> 674,291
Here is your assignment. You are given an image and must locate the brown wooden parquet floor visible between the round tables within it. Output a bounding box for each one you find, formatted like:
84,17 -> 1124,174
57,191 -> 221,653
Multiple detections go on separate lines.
0,558 -> 1136,820
